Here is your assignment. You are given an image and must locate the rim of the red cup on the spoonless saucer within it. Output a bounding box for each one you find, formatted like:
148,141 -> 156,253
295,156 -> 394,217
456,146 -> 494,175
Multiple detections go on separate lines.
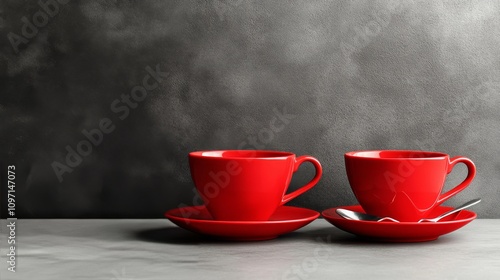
189,150 -> 295,160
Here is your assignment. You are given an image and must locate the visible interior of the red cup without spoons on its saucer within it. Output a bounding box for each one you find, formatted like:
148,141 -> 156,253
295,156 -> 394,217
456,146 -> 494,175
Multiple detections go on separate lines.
190,150 -> 293,159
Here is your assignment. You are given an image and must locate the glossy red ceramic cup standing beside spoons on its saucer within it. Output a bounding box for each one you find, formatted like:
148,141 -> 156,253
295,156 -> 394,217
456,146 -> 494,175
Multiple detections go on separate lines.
344,150 -> 476,222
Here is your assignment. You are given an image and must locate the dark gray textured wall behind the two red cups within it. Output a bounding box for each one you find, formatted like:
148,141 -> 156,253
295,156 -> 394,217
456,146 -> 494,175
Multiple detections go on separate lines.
0,0 -> 500,218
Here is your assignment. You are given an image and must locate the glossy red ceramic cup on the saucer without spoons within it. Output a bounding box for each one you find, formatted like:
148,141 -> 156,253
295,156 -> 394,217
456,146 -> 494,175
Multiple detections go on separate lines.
189,150 -> 322,221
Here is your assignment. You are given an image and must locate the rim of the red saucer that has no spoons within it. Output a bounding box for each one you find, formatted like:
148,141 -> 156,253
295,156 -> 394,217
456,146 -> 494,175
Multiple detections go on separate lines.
163,205 -> 321,225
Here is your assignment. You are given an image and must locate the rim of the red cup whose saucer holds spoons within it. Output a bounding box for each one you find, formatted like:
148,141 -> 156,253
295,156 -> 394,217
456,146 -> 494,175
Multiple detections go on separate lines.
344,150 -> 448,160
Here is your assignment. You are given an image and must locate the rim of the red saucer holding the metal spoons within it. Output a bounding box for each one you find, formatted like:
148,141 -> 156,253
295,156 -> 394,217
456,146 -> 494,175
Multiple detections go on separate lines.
321,204 -> 477,226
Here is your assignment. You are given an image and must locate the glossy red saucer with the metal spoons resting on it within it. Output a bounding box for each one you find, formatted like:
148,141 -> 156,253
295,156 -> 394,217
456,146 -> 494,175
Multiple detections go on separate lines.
321,205 -> 477,242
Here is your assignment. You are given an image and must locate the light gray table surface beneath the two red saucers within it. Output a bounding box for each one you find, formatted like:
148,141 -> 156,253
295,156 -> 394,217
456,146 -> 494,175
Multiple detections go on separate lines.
0,219 -> 500,280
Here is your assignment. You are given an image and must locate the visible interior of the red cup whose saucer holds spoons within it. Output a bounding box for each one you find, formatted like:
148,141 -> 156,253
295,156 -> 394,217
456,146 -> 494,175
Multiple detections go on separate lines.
346,150 -> 446,159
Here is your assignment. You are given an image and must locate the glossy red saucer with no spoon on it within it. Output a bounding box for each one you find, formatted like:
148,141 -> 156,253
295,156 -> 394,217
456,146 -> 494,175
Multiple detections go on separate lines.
165,206 -> 319,241
